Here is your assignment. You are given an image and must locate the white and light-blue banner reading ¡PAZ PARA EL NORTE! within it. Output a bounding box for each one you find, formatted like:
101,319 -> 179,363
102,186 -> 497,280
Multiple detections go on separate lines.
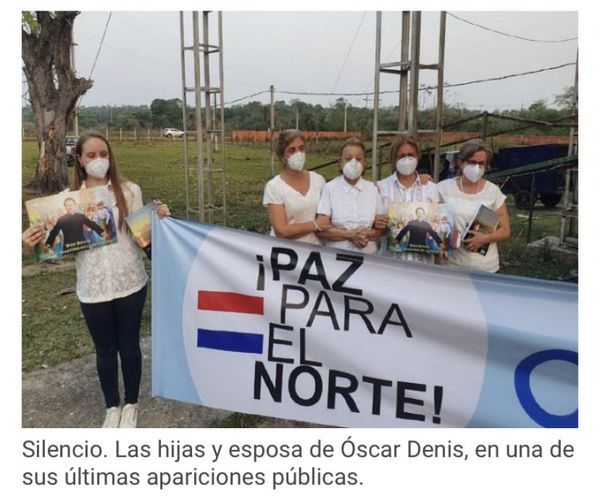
152,219 -> 577,427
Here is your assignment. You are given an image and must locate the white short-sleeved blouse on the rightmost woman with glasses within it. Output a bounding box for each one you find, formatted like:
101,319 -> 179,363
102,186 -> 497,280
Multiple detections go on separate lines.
438,178 -> 506,273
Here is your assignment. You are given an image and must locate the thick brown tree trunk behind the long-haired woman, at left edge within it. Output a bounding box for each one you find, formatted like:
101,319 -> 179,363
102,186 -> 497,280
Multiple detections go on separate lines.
21,11 -> 93,193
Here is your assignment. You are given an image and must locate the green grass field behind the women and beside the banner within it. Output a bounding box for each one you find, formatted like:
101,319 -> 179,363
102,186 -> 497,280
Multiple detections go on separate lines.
22,140 -> 576,371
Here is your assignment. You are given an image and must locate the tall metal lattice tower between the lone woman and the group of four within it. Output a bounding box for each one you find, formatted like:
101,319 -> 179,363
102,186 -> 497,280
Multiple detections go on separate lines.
179,11 -> 227,224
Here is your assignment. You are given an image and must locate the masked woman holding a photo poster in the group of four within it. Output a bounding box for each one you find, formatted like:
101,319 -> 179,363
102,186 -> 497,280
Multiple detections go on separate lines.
375,135 -> 440,264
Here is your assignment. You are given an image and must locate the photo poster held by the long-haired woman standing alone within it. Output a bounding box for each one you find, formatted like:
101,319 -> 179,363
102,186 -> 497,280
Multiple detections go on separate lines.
25,186 -> 117,261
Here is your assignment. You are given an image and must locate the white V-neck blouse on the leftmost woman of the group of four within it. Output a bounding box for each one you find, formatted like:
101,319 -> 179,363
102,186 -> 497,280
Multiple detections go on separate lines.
263,171 -> 325,245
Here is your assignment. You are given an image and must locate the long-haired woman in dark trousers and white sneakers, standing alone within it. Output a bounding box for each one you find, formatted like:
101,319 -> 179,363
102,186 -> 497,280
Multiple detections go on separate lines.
23,133 -> 170,428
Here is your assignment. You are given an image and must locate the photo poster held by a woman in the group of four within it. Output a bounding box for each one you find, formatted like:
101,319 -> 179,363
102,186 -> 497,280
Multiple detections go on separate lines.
386,202 -> 460,254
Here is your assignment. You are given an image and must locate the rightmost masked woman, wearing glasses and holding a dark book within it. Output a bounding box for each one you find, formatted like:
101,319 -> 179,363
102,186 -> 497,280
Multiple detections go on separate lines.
438,139 -> 510,273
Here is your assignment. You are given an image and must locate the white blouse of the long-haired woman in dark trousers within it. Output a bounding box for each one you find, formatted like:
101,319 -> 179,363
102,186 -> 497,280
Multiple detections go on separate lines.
75,182 -> 148,304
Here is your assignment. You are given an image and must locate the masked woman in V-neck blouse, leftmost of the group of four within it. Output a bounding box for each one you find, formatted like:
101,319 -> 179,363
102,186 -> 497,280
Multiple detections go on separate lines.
263,129 -> 329,245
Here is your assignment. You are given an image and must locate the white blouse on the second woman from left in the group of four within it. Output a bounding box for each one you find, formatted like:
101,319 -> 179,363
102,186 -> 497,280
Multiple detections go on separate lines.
317,176 -> 383,254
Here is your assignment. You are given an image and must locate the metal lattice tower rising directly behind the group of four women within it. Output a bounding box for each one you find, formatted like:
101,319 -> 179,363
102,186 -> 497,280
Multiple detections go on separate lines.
372,11 -> 446,181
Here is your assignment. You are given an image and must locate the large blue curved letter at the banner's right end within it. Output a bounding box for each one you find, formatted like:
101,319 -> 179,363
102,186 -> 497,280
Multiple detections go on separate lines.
515,349 -> 578,428
